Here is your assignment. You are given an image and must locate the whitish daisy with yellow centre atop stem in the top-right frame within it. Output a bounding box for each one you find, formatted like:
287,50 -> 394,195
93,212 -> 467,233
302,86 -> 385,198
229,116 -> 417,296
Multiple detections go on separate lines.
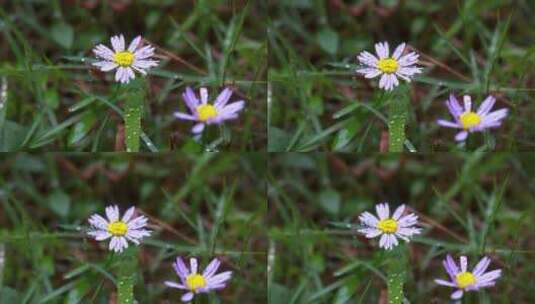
357,42 -> 422,91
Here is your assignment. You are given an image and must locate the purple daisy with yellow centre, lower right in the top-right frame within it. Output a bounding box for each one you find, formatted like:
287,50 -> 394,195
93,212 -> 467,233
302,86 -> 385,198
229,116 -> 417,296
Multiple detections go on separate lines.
437,94 -> 508,141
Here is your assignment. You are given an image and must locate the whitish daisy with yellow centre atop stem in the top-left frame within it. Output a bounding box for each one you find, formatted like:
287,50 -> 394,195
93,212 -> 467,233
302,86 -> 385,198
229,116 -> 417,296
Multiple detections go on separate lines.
93,35 -> 158,83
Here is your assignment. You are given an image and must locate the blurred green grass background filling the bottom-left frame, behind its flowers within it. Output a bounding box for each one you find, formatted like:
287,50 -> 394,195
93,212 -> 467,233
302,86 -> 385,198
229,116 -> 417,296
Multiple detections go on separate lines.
0,153 -> 267,304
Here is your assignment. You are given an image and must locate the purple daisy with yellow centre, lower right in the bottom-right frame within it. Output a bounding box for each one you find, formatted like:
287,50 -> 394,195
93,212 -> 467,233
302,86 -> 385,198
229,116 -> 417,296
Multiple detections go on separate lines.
435,254 -> 502,300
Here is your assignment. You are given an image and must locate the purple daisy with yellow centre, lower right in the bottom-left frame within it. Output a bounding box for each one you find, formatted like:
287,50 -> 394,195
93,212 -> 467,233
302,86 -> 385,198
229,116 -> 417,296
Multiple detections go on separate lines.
165,257 -> 232,302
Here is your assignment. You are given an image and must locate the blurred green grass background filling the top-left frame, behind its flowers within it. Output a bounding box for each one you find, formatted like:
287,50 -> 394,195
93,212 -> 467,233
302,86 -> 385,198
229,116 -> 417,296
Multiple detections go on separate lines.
0,0 -> 267,151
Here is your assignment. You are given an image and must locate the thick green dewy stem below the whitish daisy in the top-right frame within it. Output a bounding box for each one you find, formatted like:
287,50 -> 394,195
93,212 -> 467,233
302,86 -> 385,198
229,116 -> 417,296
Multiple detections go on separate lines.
388,87 -> 409,152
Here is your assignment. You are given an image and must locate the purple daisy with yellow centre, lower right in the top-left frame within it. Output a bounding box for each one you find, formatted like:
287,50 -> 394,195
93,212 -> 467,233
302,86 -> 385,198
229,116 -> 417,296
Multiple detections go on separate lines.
174,87 -> 245,134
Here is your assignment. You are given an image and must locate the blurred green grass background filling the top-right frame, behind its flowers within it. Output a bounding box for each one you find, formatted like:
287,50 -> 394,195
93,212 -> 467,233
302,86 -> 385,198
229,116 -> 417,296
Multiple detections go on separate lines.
267,0 -> 535,152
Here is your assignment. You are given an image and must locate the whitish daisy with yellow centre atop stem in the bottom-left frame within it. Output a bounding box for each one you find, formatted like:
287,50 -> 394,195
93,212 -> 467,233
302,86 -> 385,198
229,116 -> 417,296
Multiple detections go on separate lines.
88,206 -> 151,252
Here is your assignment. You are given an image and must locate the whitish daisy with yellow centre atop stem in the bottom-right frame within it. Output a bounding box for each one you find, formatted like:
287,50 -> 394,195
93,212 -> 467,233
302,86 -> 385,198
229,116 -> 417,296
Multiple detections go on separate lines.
358,203 -> 421,250
